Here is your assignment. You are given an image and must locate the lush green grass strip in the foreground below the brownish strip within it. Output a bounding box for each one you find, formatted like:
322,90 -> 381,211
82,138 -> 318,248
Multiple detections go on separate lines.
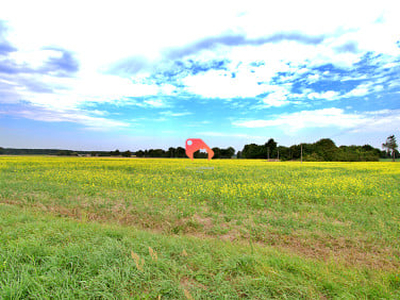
0,204 -> 400,299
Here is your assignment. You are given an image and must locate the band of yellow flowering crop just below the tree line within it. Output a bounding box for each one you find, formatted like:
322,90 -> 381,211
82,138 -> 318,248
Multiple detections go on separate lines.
0,157 -> 400,203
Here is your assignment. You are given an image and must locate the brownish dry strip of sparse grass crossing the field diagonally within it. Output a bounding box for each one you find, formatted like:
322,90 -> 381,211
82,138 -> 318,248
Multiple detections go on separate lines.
0,199 -> 400,270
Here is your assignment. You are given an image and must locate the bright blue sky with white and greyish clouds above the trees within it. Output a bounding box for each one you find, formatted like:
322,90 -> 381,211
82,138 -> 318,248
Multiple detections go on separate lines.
0,0 -> 400,151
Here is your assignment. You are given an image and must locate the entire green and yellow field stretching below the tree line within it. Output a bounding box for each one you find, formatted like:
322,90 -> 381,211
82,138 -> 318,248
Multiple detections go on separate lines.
0,156 -> 400,299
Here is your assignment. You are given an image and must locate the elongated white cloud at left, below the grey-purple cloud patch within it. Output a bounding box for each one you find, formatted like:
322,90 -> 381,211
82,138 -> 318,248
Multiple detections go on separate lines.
0,73 -> 175,109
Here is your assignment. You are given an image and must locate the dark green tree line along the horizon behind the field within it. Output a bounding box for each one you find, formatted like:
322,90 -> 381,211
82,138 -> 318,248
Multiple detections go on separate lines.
0,135 -> 399,161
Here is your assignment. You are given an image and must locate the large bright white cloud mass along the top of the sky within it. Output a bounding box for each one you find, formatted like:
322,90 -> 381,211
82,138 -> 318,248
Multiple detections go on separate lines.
0,0 -> 400,67
